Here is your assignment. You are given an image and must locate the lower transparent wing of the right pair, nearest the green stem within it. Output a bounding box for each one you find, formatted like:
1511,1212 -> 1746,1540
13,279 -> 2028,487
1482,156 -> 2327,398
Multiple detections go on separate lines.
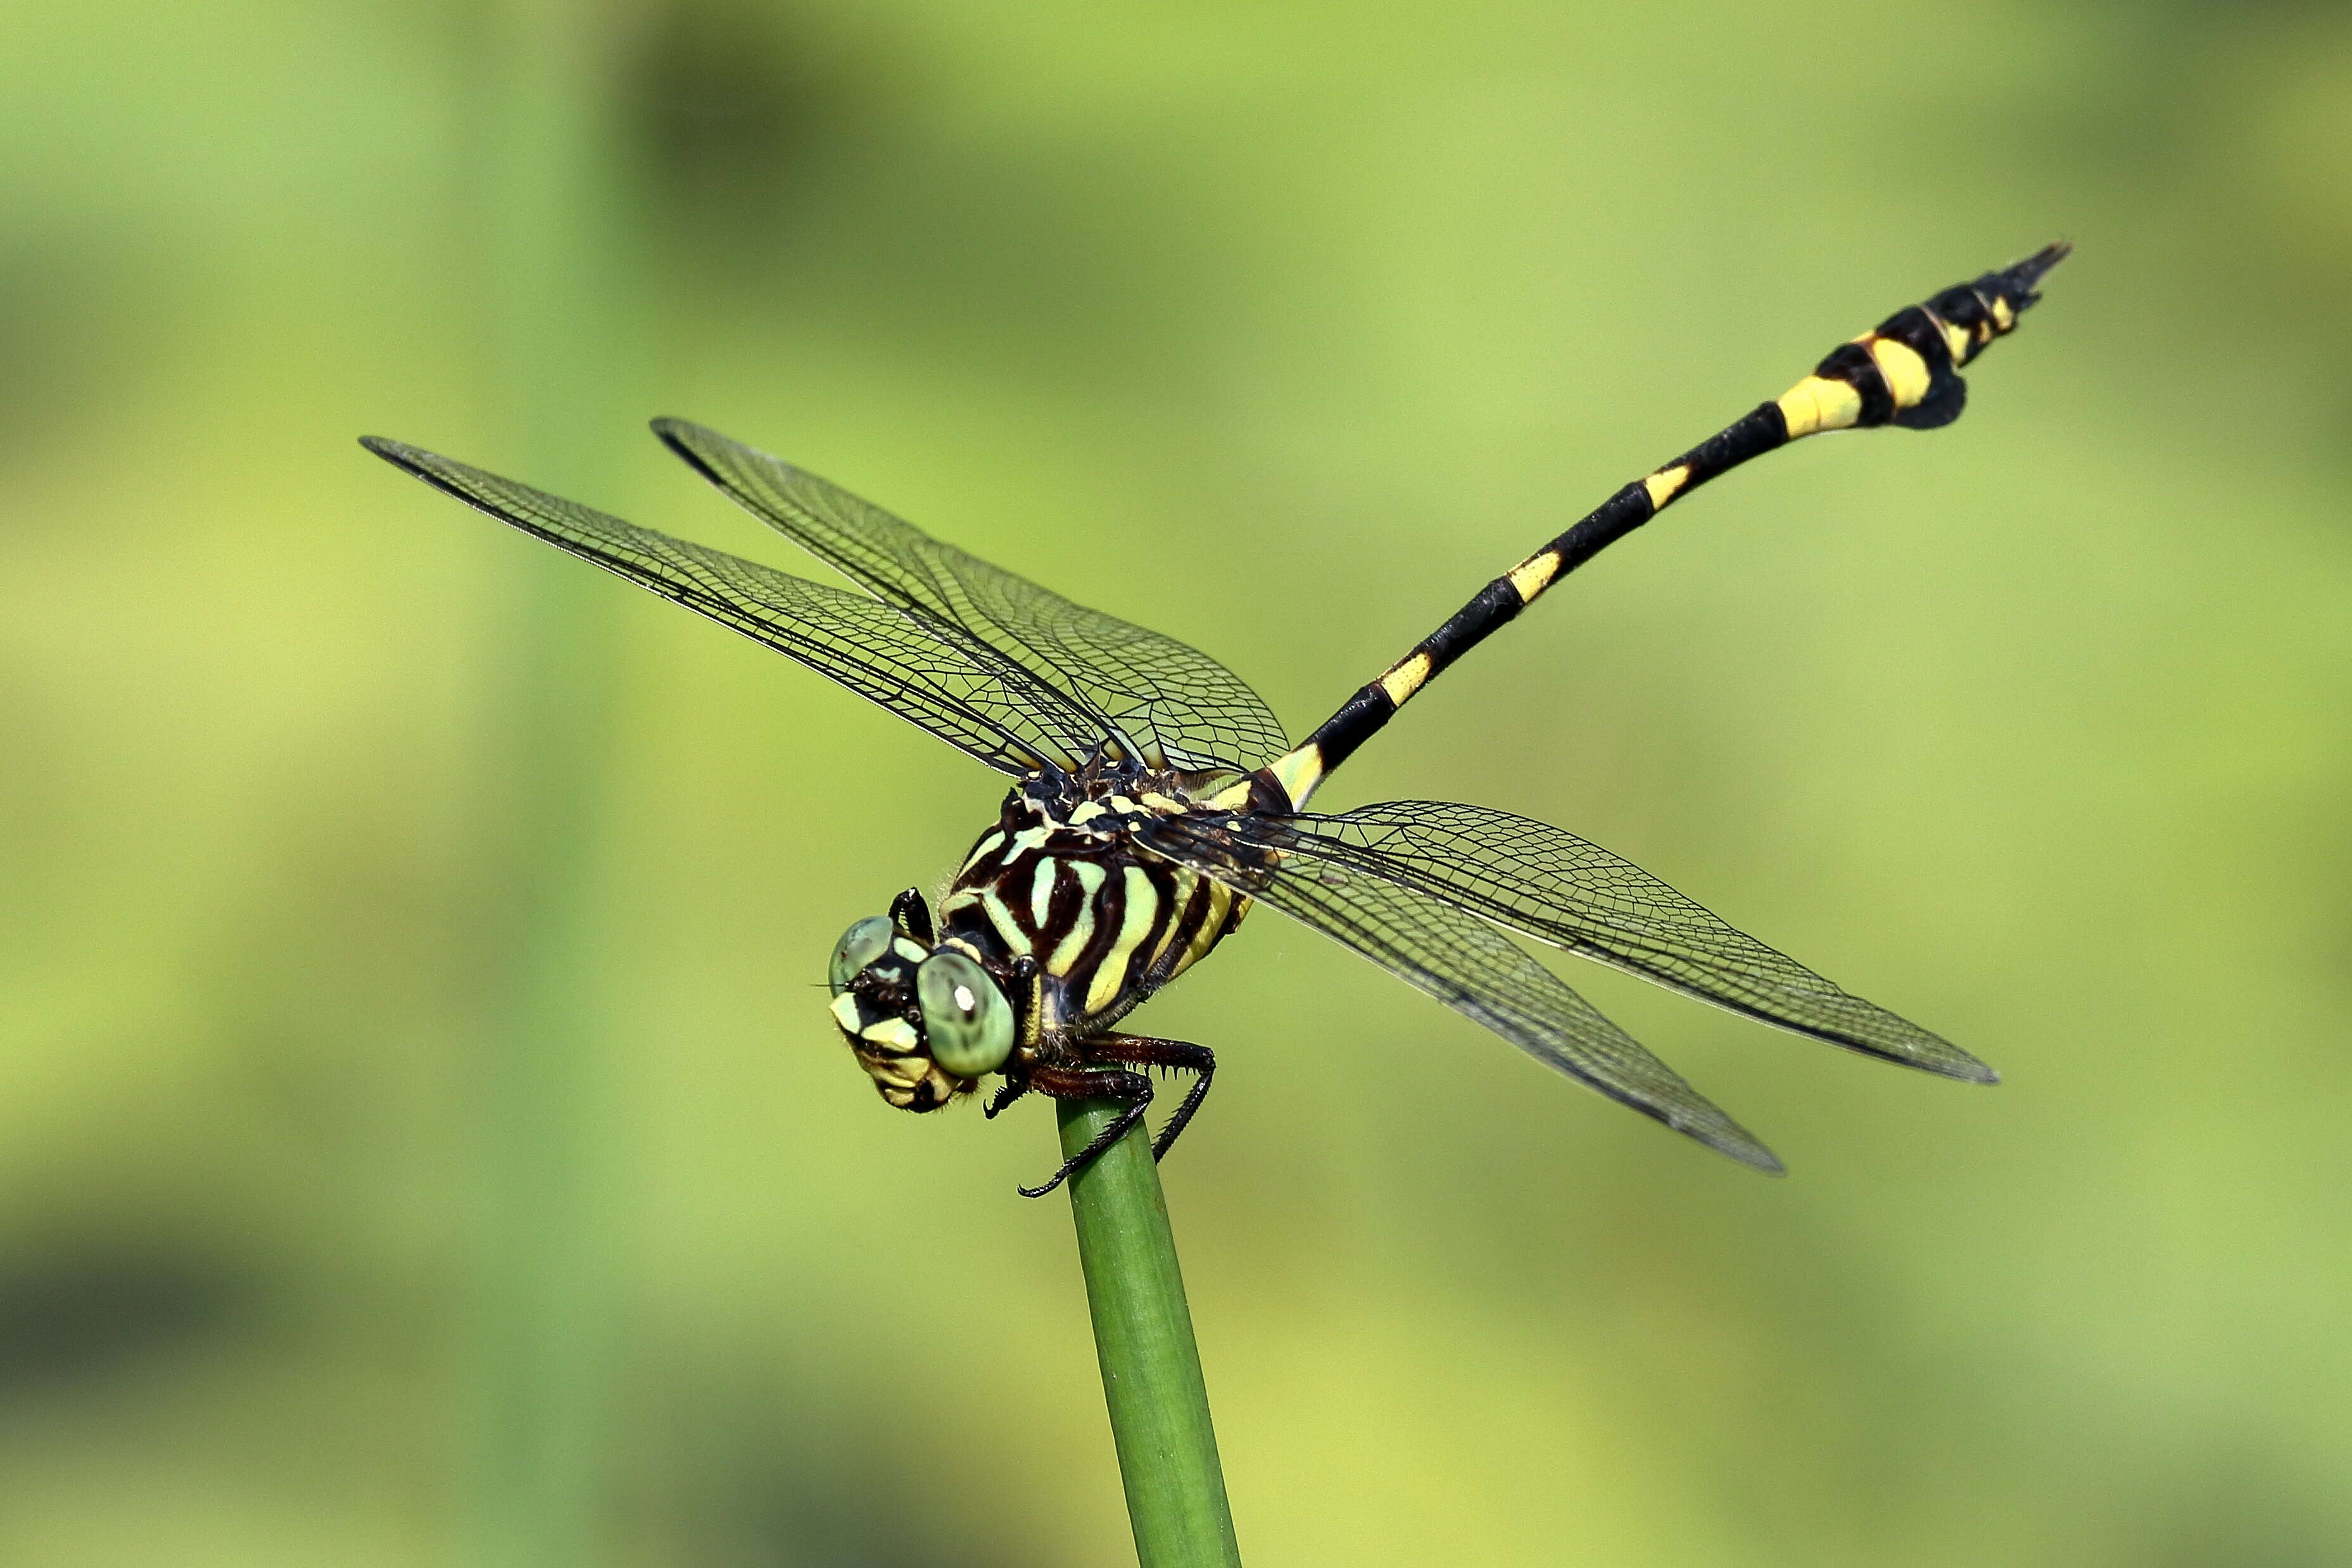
1134,813 -> 1780,1173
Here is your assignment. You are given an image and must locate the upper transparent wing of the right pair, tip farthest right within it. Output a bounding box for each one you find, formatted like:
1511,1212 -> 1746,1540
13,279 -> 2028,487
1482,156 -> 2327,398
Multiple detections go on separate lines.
1204,799 -> 1997,1084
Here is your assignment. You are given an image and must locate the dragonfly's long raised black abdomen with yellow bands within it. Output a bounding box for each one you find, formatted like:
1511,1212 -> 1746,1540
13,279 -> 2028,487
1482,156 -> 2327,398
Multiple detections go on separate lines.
1218,242 -> 2072,809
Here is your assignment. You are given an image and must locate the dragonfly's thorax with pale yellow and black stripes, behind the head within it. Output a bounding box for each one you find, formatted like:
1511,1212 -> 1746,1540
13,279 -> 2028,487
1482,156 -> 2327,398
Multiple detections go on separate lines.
939,771 -> 1249,1034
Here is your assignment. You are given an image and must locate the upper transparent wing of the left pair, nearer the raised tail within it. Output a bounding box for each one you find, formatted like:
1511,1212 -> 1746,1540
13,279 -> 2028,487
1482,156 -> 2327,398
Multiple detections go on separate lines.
654,419 -> 1289,771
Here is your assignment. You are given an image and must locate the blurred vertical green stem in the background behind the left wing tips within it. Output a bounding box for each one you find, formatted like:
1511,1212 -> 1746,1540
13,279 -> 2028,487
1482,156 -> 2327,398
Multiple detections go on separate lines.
458,0 -> 626,1568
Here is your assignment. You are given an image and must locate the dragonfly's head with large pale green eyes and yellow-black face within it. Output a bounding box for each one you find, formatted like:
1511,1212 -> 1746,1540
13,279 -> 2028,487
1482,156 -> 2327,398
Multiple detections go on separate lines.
826,888 -> 1014,1110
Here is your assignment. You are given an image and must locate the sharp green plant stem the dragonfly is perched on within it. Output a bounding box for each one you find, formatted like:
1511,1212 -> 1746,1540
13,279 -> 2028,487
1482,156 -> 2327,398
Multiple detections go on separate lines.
1056,1100 -> 1242,1568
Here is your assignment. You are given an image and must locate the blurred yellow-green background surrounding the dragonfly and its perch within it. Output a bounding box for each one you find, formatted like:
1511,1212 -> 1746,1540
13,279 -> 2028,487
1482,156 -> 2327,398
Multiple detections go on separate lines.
0,0 -> 2352,1568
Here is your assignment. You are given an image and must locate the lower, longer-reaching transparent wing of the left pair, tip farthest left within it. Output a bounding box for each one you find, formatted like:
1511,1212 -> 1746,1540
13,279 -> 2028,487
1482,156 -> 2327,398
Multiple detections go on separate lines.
362,435 -> 1101,773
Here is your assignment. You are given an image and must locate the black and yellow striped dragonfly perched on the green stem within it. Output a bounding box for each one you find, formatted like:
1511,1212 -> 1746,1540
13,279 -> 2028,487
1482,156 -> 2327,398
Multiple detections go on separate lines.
362,242 -> 2068,1196
